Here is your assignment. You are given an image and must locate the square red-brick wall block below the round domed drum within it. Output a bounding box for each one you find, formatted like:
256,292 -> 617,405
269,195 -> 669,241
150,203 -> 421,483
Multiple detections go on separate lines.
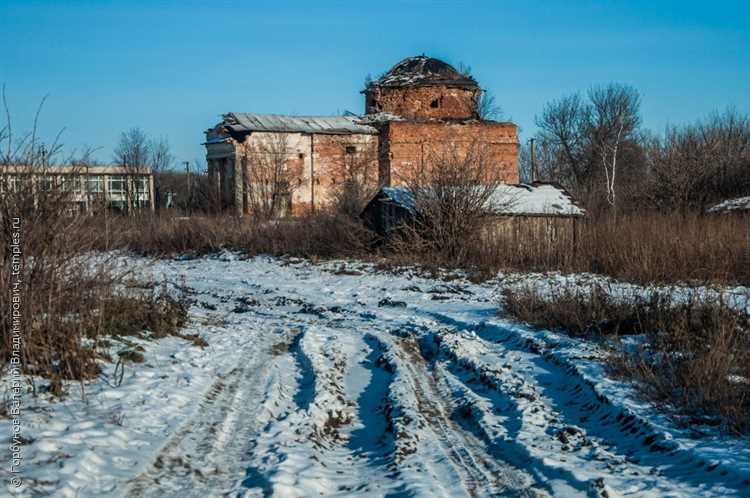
379,121 -> 519,185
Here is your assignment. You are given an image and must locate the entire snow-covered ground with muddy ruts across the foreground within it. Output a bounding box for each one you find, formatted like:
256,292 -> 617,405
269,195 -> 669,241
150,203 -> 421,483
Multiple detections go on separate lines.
0,254 -> 750,497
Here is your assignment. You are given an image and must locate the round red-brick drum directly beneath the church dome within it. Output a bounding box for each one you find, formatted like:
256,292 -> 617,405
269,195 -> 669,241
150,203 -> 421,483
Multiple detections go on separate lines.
365,86 -> 479,119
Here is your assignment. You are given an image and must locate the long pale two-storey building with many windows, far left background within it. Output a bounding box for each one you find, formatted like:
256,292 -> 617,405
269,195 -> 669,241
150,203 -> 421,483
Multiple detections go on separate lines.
0,165 -> 154,214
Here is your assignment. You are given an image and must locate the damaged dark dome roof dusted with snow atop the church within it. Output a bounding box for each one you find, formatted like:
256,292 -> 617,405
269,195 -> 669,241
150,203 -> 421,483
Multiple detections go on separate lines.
368,55 -> 478,88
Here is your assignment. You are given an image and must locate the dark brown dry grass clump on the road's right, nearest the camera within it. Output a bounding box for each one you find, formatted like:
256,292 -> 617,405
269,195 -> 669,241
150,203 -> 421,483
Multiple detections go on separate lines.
502,286 -> 750,433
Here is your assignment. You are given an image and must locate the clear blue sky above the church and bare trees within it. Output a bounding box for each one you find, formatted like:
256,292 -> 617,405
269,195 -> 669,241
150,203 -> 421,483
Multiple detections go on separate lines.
0,0 -> 750,167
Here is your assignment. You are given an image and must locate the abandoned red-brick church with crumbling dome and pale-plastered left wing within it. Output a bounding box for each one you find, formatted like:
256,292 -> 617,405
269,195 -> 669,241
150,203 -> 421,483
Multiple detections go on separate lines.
205,56 -> 519,216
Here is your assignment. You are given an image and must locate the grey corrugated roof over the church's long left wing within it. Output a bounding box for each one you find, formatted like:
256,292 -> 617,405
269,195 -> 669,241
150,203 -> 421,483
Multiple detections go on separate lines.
224,112 -> 378,135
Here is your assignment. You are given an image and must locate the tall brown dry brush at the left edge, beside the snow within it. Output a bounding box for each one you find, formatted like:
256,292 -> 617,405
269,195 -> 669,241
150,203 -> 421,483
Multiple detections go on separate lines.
0,191 -> 191,386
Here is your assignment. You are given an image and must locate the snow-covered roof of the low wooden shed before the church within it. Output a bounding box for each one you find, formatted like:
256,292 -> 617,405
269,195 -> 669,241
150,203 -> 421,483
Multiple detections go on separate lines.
381,182 -> 586,216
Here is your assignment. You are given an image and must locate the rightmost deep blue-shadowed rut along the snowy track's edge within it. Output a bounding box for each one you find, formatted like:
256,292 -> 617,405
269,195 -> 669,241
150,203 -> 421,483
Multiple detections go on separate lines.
430,313 -> 750,494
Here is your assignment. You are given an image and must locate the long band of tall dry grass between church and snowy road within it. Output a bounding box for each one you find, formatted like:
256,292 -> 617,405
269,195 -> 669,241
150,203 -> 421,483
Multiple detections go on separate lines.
97,208 -> 750,290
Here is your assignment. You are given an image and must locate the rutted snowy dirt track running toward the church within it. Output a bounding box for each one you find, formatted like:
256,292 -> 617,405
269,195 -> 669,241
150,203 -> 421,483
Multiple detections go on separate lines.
108,256 -> 748,497
